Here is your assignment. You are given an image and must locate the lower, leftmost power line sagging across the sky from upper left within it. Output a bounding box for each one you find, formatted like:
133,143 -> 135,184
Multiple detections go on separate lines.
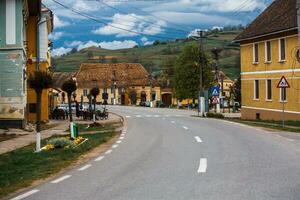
52,0 -> 177,40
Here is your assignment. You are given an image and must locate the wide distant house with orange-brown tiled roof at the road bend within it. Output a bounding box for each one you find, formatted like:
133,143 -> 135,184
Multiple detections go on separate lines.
54,63 -> 161,105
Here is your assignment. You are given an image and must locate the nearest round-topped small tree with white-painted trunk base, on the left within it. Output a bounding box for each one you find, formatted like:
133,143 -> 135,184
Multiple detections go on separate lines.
28,71 -> 53,151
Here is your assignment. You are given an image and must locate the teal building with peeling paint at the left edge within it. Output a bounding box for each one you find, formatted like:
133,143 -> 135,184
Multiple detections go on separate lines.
0,0 -> 40,128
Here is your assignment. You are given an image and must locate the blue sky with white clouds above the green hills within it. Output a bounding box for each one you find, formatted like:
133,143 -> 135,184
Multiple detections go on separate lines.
43,0 -> 272,56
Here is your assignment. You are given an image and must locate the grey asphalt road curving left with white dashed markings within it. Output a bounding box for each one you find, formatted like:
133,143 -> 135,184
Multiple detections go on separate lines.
11,106 -> 300,200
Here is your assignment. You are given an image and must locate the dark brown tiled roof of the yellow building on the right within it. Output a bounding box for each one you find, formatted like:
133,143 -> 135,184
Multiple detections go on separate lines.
235,0 -> 298,42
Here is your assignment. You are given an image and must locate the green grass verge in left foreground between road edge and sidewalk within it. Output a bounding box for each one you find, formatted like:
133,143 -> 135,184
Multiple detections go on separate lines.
0,130 -> 116,198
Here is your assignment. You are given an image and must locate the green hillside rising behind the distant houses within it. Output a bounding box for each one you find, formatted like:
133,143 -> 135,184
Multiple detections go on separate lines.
53,31 -> 240,79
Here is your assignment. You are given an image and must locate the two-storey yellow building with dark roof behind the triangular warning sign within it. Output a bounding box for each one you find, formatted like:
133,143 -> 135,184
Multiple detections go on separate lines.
235,0 -> 300,120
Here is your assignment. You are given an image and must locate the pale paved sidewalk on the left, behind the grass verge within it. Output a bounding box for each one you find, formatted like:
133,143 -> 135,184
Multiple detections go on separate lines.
0,113 -> 123,154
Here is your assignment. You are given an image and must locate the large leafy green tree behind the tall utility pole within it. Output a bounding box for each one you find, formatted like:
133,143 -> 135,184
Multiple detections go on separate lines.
173,45 -> 213,100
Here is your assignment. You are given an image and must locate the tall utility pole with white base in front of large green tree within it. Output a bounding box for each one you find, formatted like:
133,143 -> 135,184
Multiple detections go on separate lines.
198,30 -> 205,117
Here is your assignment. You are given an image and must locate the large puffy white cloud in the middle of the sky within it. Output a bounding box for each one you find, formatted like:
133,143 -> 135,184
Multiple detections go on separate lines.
93,13 -> 166,37
